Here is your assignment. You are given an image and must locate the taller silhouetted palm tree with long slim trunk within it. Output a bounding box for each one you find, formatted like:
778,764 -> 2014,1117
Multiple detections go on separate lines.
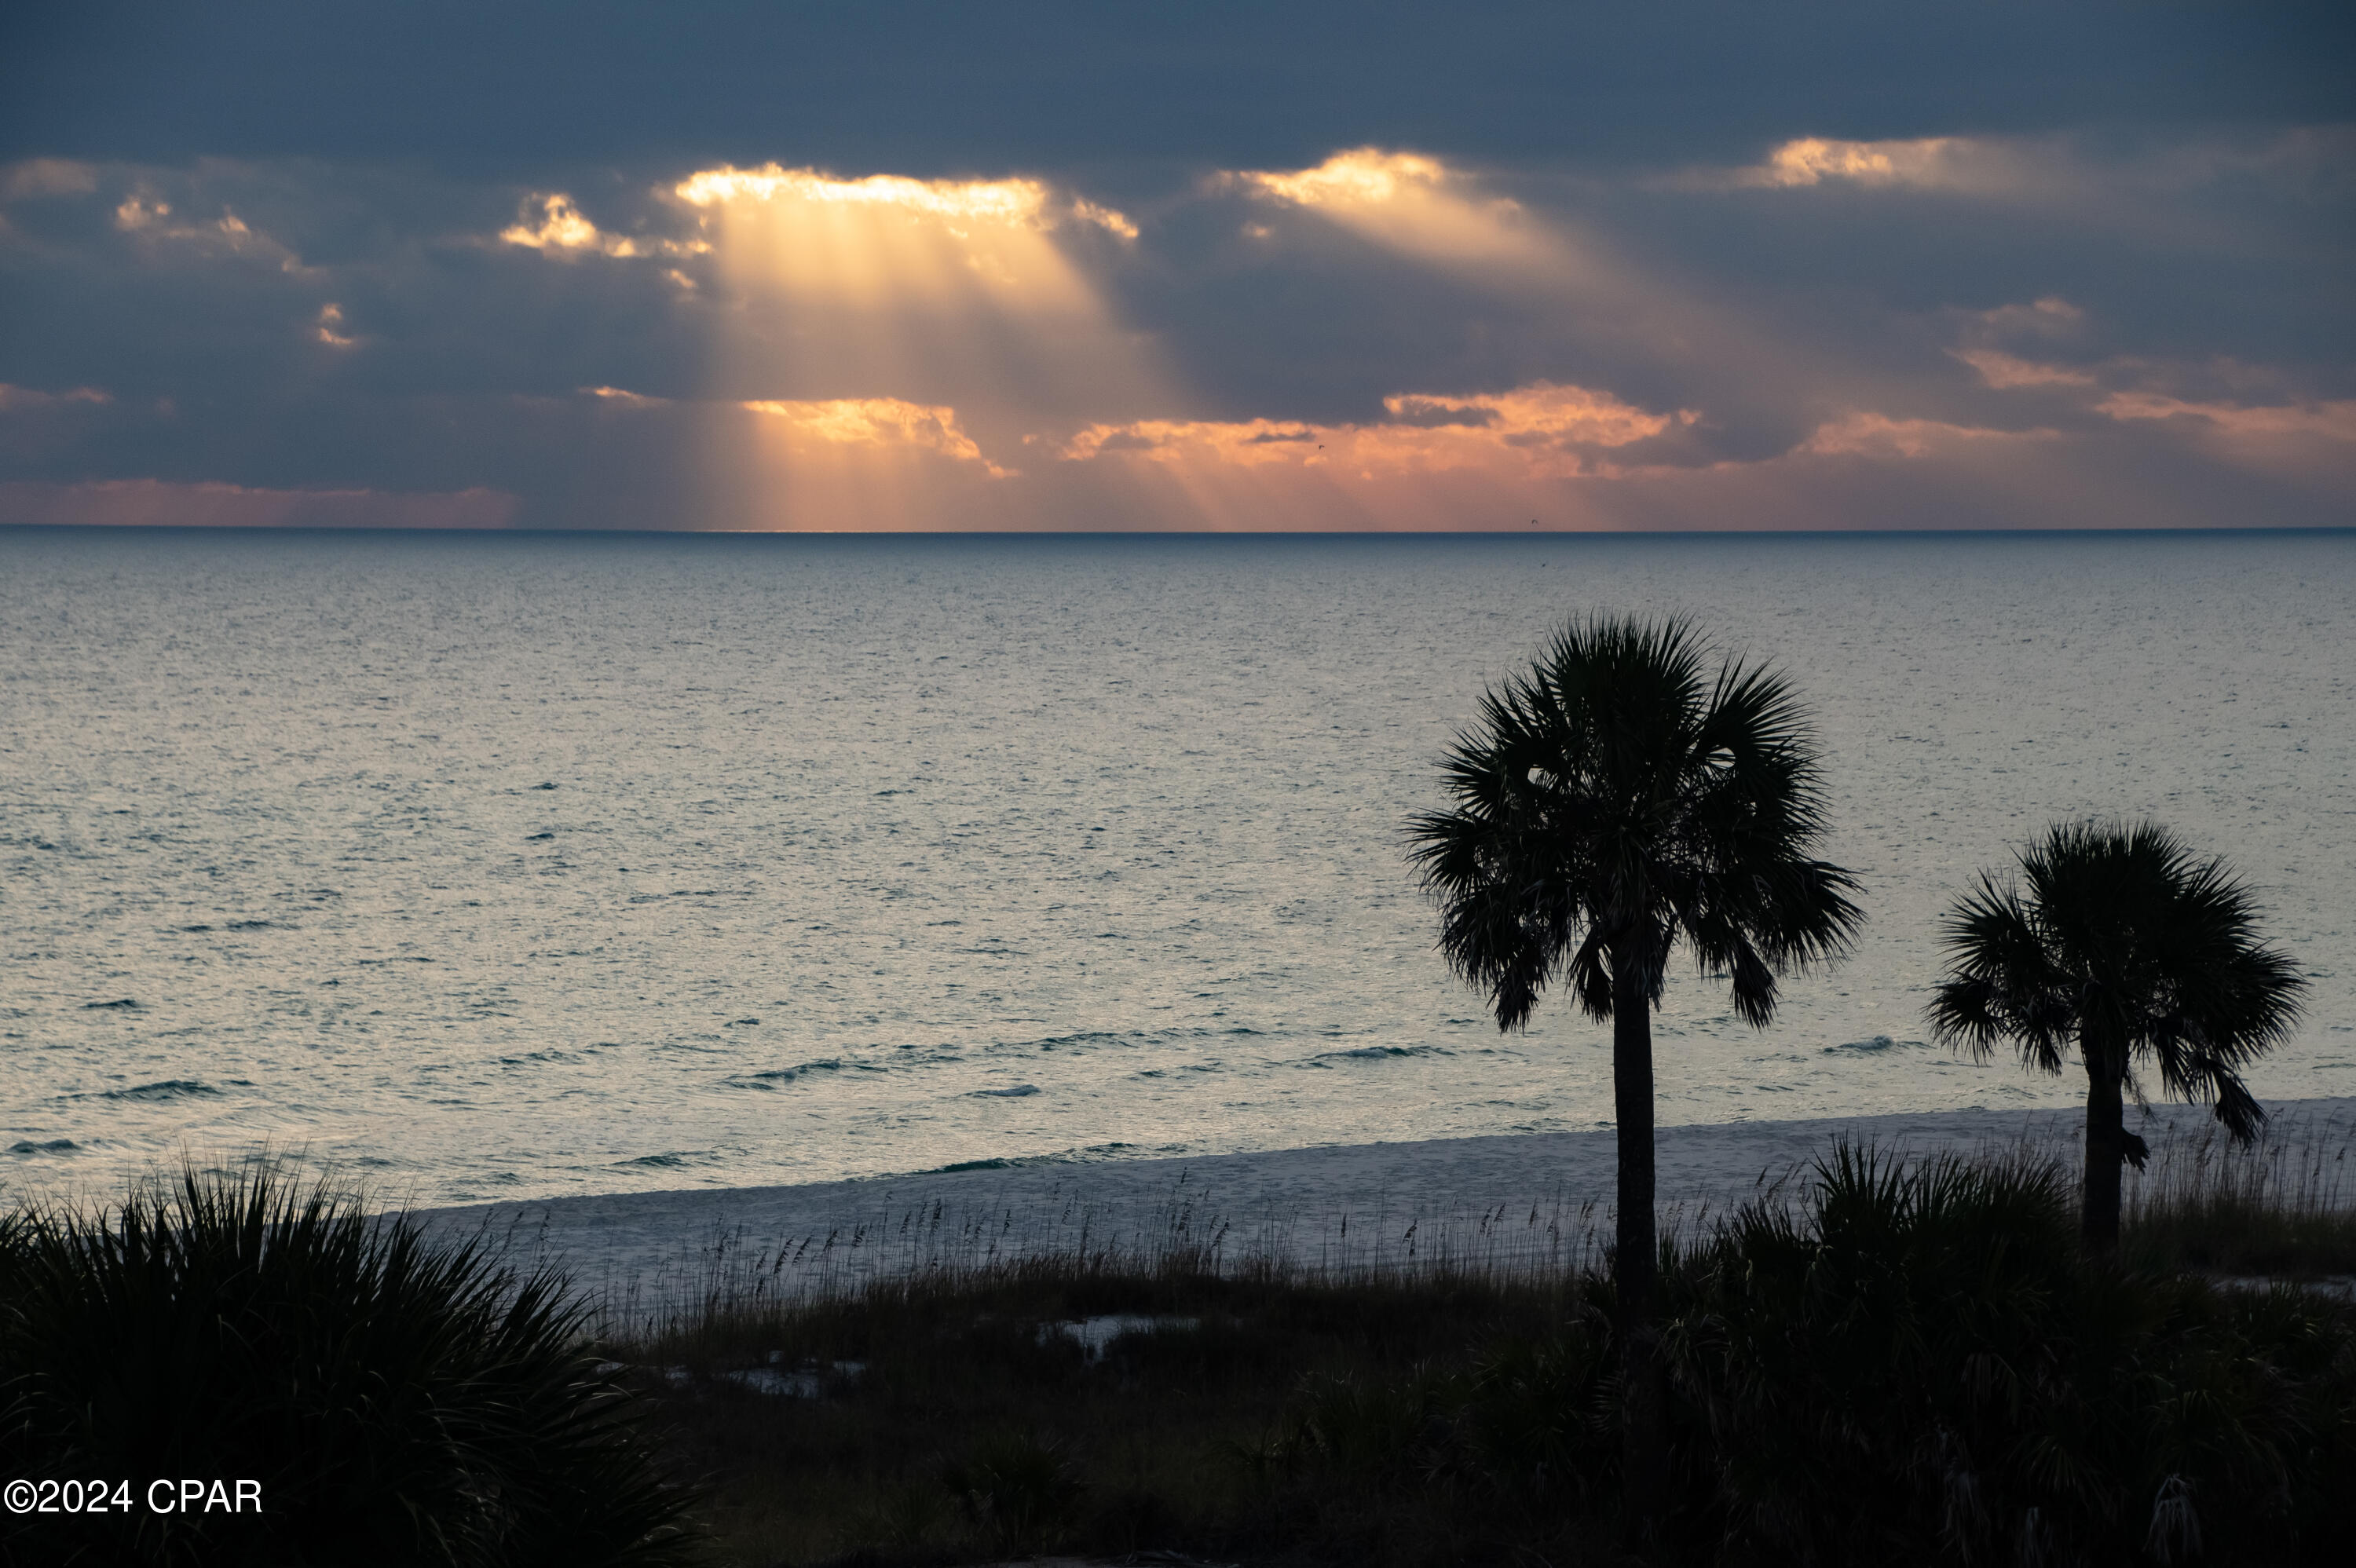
1409,620 -> 1859,1526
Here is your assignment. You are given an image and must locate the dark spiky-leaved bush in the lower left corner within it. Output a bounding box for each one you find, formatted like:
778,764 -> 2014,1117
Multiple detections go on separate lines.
0,1160 -> 690,1566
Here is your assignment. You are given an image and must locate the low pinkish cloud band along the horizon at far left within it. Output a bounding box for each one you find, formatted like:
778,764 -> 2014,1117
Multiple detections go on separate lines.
0,478 -> 523,528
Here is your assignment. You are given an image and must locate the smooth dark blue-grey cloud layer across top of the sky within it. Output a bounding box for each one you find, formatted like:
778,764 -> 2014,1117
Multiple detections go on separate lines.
0,0 -> 2356,177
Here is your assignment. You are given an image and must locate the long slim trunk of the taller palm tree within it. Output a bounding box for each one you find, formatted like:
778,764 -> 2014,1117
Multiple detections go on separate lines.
1612,953 -> 1668,1535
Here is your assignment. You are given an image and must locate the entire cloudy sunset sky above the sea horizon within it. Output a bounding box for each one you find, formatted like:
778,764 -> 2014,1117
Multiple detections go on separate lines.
0,0 -> 2356,532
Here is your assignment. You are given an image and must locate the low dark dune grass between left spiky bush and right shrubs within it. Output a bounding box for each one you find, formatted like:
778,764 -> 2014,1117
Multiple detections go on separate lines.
615,1252 -> 1576,1563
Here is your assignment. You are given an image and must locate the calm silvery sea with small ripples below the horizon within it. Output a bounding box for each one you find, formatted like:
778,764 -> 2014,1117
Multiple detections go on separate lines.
0,532 -> 2356,1203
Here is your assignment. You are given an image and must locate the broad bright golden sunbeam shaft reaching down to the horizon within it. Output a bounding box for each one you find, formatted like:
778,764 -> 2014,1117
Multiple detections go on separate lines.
674,165 -> 1166,528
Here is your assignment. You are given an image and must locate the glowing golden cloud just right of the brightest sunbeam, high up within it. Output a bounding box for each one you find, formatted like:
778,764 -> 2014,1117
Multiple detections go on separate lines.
1213,146 -> 1560,264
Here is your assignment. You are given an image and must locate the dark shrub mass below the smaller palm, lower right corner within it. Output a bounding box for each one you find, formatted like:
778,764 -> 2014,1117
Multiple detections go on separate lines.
1675,1146 -> 2356,1563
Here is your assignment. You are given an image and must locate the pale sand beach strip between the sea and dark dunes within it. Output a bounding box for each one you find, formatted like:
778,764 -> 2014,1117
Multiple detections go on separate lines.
417,1097 -> 2356,1311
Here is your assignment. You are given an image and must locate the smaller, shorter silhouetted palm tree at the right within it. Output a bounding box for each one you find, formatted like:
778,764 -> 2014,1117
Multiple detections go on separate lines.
1930,821 -> 2307,1255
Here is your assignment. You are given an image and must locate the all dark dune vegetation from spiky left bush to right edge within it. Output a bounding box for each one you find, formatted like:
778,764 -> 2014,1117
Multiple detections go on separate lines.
613,1149 -> 2356,1566
